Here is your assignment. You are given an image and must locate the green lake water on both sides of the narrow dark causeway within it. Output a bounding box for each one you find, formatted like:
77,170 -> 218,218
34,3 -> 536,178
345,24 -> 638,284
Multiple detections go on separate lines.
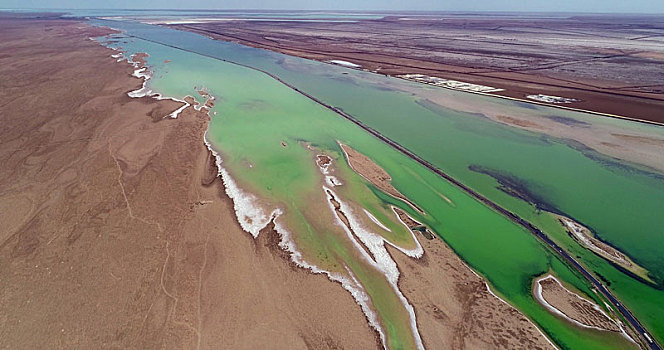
97,21 -> 664,349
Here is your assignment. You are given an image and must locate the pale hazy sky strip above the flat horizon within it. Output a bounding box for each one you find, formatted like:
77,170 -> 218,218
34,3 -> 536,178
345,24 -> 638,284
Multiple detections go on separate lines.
0,0 -> 664,13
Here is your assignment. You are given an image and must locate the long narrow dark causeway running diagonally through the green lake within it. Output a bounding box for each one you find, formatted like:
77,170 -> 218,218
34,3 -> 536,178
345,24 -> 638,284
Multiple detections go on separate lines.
118,28 -> 662,350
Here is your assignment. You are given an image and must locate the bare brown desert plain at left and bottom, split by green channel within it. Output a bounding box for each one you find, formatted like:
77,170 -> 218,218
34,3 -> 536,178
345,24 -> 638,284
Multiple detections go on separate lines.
0,17 -> 564,349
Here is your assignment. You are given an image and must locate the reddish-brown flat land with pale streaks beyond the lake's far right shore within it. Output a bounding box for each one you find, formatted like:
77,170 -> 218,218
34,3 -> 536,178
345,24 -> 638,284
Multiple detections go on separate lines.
172,14 -> 664,123
